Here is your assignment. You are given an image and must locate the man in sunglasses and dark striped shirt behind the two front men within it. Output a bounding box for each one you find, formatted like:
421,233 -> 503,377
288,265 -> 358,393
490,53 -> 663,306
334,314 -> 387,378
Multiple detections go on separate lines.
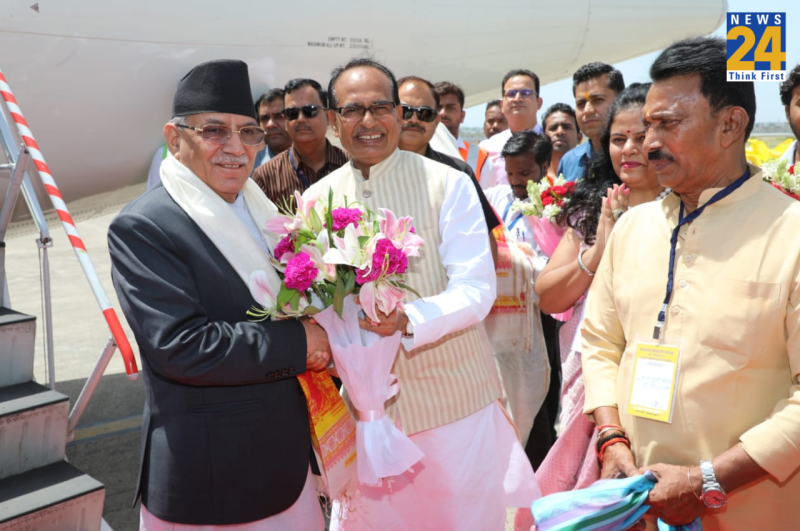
253,78 -> 348,206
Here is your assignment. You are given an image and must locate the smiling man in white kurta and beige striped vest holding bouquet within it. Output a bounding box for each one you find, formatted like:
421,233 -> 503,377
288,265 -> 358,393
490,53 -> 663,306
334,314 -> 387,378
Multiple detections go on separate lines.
316,59 -> 539,531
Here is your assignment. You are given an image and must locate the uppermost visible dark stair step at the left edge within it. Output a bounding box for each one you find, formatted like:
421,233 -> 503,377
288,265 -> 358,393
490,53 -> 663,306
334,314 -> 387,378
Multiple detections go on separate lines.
0,308 -> 36,387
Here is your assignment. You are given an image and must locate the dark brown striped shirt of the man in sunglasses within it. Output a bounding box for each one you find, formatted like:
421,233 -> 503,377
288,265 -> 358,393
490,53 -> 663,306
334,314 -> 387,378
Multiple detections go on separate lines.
253,138 -> 350,208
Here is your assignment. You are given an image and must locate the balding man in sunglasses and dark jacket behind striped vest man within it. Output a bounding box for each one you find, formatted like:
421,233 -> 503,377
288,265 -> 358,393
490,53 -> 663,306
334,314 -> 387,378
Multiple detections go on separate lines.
397,76 -> 500,262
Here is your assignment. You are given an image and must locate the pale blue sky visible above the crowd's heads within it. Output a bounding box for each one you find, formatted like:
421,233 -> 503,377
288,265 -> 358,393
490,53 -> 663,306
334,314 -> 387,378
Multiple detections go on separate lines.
464,0 -> 800,128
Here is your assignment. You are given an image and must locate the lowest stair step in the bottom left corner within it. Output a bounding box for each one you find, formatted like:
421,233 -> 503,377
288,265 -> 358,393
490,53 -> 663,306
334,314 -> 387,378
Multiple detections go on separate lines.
0,461 -> 105,531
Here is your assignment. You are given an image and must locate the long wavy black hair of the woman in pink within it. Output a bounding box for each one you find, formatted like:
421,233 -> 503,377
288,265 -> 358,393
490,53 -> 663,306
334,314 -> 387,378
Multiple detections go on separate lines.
556,83 -> 651,245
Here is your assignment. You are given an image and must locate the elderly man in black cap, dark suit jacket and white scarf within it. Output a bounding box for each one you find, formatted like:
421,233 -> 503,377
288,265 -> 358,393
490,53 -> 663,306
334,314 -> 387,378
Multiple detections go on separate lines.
109,60 -> 330,531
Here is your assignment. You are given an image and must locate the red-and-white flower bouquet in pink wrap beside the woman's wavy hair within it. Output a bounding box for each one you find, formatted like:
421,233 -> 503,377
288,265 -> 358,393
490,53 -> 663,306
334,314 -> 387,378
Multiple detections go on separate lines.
511,174 -> 575,256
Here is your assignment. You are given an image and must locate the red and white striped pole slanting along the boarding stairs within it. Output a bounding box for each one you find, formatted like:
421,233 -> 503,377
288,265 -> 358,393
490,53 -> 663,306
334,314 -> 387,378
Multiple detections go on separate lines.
0,70 -> 139,380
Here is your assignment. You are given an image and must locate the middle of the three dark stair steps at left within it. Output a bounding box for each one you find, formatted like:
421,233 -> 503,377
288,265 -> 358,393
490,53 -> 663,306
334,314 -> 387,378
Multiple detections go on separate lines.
0,382 -> 69,480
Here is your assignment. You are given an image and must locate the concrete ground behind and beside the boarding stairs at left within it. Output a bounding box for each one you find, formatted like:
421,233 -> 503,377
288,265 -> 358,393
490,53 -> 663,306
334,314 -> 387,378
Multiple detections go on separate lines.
6,187 -> 513,531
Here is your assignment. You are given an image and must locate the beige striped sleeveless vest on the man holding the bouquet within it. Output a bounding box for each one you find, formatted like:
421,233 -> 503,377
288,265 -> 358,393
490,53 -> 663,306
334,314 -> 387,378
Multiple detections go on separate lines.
312,150 -> 501,434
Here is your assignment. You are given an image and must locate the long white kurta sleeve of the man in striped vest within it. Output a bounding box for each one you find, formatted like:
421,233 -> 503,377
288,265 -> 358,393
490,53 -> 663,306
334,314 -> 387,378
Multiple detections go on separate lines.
403,170 -> 497,350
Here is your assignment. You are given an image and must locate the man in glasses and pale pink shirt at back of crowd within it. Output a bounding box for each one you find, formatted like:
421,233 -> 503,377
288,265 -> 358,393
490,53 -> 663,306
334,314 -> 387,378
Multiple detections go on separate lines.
480,69 -> 542,188
